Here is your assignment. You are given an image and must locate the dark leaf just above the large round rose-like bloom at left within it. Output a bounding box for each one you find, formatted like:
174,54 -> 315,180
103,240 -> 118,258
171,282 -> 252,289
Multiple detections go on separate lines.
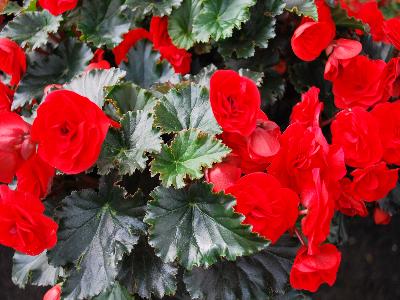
12,38 -> 93,110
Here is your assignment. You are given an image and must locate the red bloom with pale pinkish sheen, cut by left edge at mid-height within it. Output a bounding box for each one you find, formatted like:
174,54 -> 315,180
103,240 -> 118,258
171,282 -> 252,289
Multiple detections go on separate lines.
0,112 -> 35,183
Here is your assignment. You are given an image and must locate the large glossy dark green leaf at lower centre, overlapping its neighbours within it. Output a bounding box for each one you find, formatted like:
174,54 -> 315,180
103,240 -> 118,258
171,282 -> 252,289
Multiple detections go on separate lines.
145,183 -> 268,269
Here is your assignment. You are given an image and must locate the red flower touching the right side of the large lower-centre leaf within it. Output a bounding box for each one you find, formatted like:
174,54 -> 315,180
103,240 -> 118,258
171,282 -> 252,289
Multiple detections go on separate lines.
226,173 -> 299,243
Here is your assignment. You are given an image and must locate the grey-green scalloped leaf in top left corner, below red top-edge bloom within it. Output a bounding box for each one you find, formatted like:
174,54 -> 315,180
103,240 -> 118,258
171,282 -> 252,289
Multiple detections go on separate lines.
0,10 -> 62,49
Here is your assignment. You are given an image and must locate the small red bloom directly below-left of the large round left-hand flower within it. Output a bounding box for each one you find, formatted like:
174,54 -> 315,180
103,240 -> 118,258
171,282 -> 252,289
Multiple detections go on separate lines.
16,155 -> 55,199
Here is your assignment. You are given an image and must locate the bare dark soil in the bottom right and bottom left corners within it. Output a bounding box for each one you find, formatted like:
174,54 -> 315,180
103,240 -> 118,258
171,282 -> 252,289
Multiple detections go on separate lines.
0,216 -> 400,300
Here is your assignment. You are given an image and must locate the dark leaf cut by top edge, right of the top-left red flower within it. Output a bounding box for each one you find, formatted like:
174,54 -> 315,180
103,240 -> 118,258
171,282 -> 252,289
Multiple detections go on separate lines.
77,0 -> 131,48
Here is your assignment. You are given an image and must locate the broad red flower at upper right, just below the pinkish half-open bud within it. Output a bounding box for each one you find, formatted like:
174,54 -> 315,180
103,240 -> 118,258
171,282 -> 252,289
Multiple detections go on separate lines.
332,55 -> 388,108
